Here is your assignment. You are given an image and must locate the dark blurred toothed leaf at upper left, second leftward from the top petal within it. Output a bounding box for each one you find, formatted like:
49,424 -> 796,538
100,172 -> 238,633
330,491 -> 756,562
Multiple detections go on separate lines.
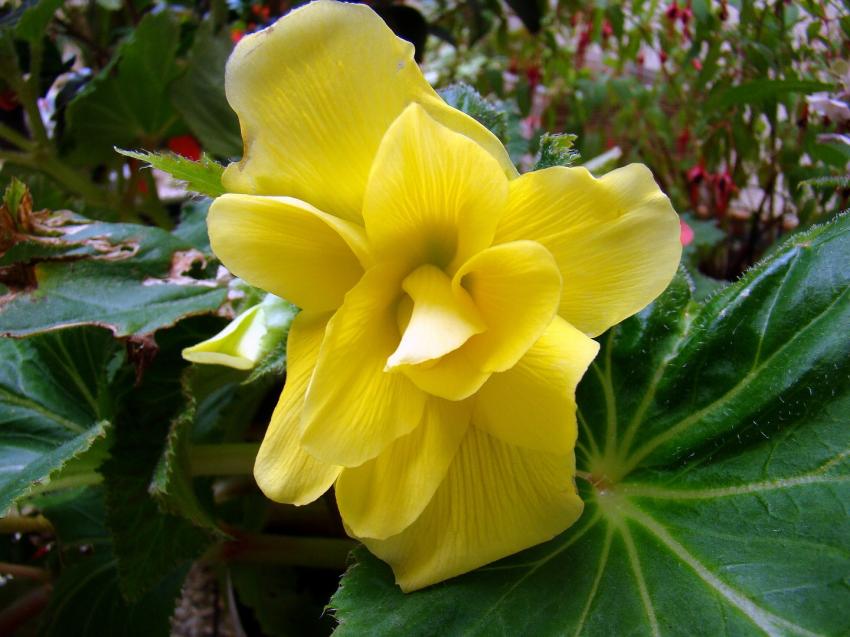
67,10 -> 180,161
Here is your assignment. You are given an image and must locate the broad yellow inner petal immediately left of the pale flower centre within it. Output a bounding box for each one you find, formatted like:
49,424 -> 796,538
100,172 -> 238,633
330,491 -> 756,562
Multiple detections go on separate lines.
301,267 -> 425,467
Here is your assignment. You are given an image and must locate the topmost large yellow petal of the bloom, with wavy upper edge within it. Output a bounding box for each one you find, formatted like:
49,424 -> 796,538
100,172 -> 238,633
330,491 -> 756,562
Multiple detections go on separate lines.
223,1 -> 515,220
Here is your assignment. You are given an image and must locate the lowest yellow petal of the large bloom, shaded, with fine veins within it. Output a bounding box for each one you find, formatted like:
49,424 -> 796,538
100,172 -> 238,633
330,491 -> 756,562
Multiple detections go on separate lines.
361,427 -> 583,592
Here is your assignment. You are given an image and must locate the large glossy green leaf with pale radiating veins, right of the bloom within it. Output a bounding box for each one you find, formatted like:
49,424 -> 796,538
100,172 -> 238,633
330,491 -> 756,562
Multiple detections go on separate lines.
332,215 -> 850,636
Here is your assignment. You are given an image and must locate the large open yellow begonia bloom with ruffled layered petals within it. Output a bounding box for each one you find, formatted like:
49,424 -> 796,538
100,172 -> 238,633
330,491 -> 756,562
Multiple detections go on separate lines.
209,0 -> 681,591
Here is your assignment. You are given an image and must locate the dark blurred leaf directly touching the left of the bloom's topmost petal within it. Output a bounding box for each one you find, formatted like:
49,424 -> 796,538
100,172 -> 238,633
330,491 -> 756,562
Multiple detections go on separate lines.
171,20 -> 242,159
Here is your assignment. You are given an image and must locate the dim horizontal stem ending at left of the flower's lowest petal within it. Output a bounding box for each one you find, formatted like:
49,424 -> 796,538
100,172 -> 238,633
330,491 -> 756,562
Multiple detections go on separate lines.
205,532 -> 357,570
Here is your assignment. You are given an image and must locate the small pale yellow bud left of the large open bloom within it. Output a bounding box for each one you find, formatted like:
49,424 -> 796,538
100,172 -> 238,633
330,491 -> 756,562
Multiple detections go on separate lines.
183,294 -> 296,370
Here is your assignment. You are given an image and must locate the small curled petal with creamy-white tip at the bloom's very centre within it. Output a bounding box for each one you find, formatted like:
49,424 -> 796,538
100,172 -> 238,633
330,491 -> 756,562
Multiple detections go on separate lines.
387,265 -> 486,368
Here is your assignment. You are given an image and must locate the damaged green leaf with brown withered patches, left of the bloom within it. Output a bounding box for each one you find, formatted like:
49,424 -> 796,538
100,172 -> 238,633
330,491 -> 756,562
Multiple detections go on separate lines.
0,213 -> 227,337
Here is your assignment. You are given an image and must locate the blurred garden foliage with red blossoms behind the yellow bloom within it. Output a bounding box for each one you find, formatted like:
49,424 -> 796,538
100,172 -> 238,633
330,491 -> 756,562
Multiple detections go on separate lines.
0,0 -> 850,291
